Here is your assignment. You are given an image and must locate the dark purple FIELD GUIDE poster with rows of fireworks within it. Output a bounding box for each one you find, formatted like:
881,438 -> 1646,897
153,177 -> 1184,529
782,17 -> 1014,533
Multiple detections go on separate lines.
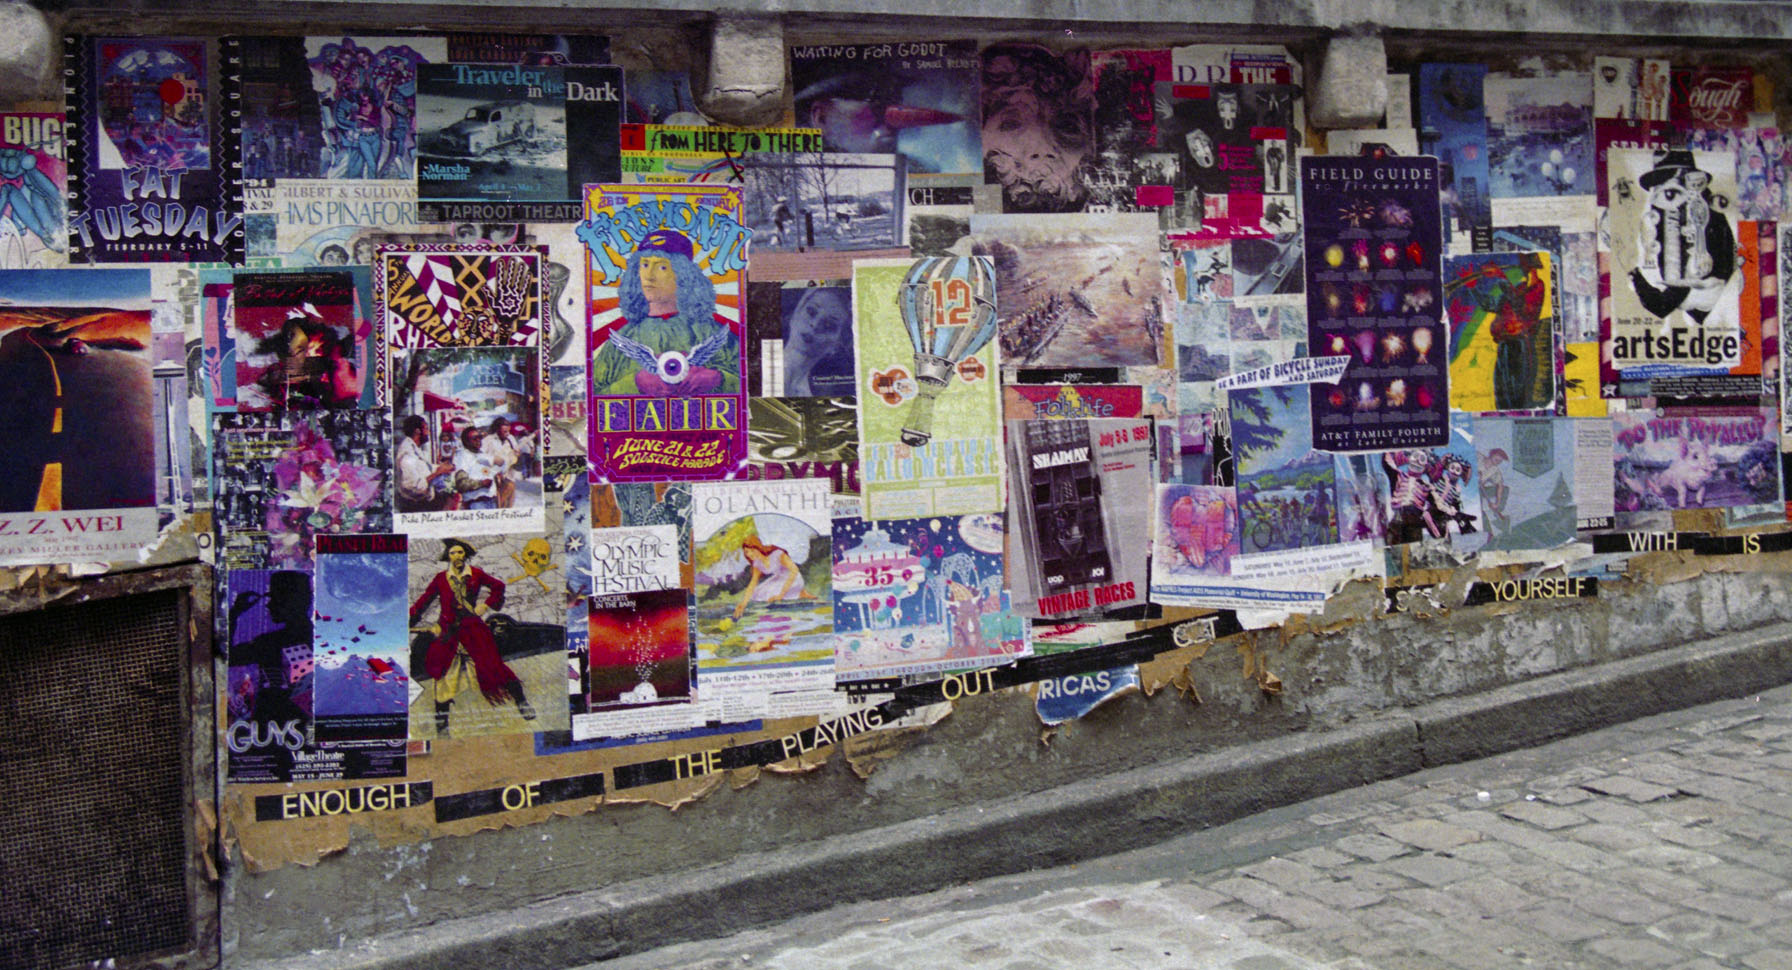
1301,156 -> 1450,452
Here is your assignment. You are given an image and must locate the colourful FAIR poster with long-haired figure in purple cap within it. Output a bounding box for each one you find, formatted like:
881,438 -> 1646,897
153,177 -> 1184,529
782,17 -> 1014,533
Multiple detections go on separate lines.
577,185 -> 753,482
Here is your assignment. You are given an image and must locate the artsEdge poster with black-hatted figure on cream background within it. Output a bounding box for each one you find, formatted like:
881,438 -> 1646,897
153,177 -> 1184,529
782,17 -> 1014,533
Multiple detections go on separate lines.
1600,149 -> 1758,389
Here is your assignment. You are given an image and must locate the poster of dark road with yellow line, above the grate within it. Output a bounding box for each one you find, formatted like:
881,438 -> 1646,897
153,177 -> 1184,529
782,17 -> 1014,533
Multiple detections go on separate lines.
0,269 -> 158,565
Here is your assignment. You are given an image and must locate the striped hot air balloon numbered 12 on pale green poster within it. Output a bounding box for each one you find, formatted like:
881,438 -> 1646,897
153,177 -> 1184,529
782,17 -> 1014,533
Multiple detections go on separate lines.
896,256 -> 996,446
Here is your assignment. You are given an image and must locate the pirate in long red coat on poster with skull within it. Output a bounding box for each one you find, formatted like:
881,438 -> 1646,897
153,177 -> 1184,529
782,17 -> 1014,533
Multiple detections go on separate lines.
410,540 -> 536,737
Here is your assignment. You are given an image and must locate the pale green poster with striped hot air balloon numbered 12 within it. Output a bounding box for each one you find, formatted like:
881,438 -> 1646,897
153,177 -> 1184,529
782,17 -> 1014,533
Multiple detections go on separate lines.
853,256 -> 1002,520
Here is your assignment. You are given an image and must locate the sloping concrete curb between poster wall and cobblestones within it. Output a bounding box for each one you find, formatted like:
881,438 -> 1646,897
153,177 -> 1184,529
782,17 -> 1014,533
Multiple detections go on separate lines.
249,624 -> 1792,970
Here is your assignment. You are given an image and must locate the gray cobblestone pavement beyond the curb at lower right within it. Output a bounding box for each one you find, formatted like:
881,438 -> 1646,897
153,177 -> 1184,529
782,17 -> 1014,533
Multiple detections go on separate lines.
588,687 -> 1792,970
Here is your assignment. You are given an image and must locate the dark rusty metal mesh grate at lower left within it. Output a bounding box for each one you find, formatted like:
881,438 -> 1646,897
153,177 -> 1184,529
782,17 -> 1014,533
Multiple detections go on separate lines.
0,590 -> 194,970
